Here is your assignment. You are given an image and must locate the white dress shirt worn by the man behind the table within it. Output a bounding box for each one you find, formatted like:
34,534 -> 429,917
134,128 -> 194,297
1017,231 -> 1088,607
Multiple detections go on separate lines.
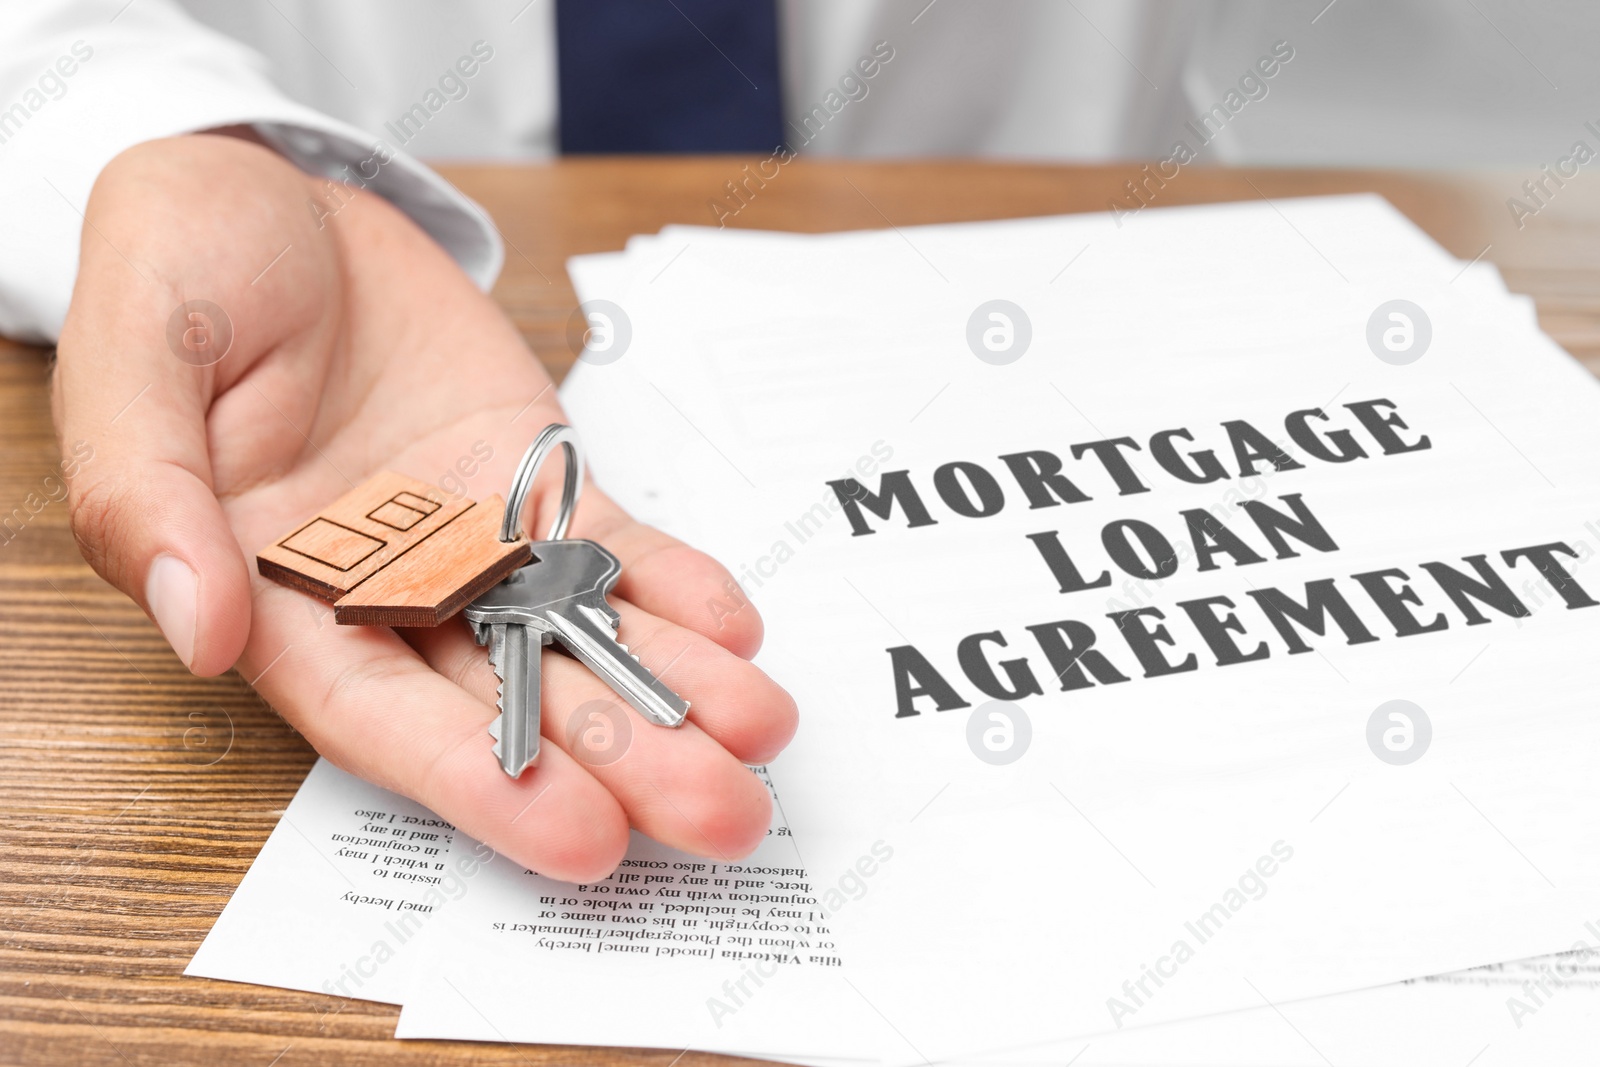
0,0 -> 1600,341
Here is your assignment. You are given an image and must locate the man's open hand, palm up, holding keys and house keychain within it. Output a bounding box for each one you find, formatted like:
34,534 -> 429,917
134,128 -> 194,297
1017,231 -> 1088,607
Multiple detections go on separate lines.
54,136 -> 795,880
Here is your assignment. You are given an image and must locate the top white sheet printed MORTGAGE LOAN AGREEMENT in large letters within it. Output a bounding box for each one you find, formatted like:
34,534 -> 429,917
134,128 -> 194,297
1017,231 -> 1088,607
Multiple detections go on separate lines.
553,200 -> 1600,1056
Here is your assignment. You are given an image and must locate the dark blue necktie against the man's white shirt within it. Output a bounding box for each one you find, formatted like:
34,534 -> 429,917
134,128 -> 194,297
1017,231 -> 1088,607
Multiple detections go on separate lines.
555,0 -> 784,152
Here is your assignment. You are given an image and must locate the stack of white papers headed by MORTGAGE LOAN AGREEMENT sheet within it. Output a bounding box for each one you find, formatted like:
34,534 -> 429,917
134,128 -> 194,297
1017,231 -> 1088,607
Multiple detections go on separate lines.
190,197 -> 1600,1065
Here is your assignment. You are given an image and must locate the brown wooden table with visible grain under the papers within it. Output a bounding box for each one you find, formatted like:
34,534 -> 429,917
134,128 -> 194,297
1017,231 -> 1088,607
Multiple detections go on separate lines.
9,158 -> 1600,1067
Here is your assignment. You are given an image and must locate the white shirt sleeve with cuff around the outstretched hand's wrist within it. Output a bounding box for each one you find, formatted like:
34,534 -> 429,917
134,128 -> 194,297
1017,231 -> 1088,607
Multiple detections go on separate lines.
0,0 -> 504,342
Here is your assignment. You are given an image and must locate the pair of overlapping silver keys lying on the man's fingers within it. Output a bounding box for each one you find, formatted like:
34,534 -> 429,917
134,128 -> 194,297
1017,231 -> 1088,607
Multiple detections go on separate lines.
464,539 -> 690,777
